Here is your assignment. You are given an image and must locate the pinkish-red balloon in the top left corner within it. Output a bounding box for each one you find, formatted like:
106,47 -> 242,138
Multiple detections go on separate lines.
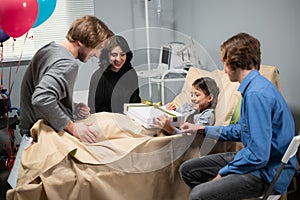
0,0 -> 38,38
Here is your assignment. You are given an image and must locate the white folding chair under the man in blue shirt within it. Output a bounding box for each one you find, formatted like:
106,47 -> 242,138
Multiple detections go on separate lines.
262,135 -> 300,200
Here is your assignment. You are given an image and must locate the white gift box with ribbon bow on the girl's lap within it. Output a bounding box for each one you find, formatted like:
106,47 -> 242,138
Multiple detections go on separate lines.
124,103 -> 184,128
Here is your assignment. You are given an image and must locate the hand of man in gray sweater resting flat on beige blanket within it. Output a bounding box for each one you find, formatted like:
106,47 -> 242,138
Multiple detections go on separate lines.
74,122 -> 98,143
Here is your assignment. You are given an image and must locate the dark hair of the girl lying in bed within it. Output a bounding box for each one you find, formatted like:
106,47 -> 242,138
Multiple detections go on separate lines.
192,77 -> 219,108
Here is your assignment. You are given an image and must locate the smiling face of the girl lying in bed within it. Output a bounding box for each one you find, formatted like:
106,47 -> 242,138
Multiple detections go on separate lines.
191,86 -> 213,112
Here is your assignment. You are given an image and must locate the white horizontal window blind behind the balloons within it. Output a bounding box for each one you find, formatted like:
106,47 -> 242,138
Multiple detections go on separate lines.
3,0 -> 94,62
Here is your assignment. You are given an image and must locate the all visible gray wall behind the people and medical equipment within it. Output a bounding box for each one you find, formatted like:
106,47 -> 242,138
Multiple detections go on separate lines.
5,0 -> 300,133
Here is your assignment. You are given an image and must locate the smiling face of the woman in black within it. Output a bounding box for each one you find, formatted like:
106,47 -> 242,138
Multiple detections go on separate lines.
109,46 -> 127,72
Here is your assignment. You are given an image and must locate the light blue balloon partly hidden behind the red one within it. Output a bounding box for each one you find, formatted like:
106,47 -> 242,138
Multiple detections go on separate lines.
32,0 -> 56,28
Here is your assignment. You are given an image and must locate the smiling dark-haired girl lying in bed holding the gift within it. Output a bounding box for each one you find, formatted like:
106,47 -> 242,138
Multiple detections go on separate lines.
153,77 -> 219,134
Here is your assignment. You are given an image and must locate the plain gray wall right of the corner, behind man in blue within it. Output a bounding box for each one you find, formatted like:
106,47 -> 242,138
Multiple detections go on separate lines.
174,0 -> 300,134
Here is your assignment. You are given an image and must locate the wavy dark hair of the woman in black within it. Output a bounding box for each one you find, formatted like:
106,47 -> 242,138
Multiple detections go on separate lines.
99,35 -> 133,69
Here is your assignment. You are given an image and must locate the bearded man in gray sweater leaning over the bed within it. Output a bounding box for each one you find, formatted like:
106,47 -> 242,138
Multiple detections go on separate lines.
19,16 -> 113,143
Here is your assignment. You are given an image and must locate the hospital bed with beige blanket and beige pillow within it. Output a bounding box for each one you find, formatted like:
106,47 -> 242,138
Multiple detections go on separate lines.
7,66 -> 281,200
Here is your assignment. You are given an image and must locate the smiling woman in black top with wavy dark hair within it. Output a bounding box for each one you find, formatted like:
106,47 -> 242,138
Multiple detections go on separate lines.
88,35 -> 141,113
